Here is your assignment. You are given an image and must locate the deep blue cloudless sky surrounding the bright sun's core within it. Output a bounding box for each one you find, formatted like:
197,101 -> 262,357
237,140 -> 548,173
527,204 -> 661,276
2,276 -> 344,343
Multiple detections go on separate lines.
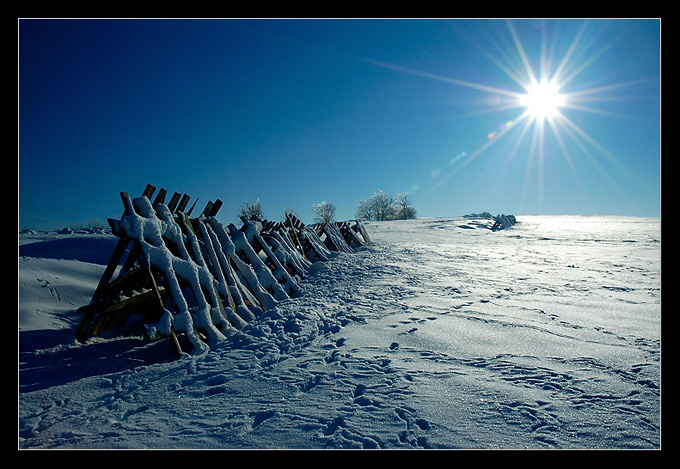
18,19 -> 660,229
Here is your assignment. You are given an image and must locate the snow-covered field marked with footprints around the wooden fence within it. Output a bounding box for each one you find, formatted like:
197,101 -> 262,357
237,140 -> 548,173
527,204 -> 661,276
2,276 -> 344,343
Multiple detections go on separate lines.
18,216 -> 661,449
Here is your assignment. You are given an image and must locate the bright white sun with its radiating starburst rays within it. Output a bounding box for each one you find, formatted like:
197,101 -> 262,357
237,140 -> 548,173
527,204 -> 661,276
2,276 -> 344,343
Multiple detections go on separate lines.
362,20 -> 658,216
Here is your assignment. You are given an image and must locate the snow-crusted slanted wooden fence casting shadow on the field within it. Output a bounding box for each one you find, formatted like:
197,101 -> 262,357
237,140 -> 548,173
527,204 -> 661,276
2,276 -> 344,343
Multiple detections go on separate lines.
76,185 -> 370,355
